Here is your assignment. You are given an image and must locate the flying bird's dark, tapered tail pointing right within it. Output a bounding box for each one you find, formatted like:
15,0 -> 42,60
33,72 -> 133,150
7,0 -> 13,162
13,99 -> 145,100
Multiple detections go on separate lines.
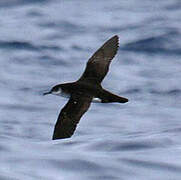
99,90 -> 128,103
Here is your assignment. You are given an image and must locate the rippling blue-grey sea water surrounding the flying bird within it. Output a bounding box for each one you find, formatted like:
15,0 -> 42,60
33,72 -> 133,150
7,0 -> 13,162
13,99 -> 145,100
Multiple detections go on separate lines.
0,0 -> 181,180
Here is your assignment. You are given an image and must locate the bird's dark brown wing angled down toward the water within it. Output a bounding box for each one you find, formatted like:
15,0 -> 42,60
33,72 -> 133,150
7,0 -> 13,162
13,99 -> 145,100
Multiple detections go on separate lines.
53,94 -> 92,140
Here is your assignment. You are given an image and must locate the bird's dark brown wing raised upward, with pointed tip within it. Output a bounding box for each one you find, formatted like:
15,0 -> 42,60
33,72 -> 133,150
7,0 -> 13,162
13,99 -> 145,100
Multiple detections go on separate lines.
79,35 -> 119,83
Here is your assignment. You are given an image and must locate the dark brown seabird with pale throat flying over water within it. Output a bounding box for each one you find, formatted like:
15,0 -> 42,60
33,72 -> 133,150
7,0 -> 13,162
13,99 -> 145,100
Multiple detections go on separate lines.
43,35 -> 128,140
